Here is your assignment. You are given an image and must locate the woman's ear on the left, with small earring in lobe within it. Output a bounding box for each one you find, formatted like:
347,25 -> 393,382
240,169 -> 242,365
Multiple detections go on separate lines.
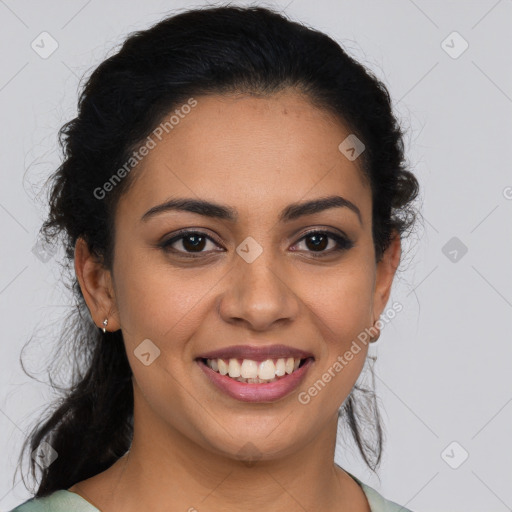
75,237 -> 120,331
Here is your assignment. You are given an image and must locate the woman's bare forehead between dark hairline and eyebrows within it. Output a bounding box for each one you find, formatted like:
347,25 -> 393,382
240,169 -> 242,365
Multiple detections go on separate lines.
119,92 -> 370,226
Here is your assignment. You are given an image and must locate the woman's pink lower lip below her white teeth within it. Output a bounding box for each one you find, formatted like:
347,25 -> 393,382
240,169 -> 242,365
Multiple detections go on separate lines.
196,358 -> 313,402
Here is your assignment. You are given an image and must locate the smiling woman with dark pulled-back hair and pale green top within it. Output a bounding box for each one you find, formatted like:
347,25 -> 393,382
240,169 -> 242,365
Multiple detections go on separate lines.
14,7 -> 418,512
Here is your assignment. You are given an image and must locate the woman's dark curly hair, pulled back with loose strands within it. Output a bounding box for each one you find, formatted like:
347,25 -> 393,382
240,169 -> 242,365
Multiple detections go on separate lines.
13,6 -> 419,497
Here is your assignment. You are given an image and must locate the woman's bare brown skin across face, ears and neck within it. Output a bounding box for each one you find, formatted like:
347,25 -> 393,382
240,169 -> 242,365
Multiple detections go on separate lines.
70,90 -> 401,512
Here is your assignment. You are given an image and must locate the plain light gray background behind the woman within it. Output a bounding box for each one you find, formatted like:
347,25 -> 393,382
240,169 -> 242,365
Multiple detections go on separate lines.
0,0 -> 512,512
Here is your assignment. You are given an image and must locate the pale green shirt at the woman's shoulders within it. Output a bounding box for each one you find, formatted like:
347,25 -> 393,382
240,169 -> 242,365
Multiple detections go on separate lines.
10,470 -> 412,512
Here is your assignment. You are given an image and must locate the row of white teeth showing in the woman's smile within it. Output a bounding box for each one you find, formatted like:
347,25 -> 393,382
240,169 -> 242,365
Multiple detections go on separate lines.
198,357 -> 313,384
